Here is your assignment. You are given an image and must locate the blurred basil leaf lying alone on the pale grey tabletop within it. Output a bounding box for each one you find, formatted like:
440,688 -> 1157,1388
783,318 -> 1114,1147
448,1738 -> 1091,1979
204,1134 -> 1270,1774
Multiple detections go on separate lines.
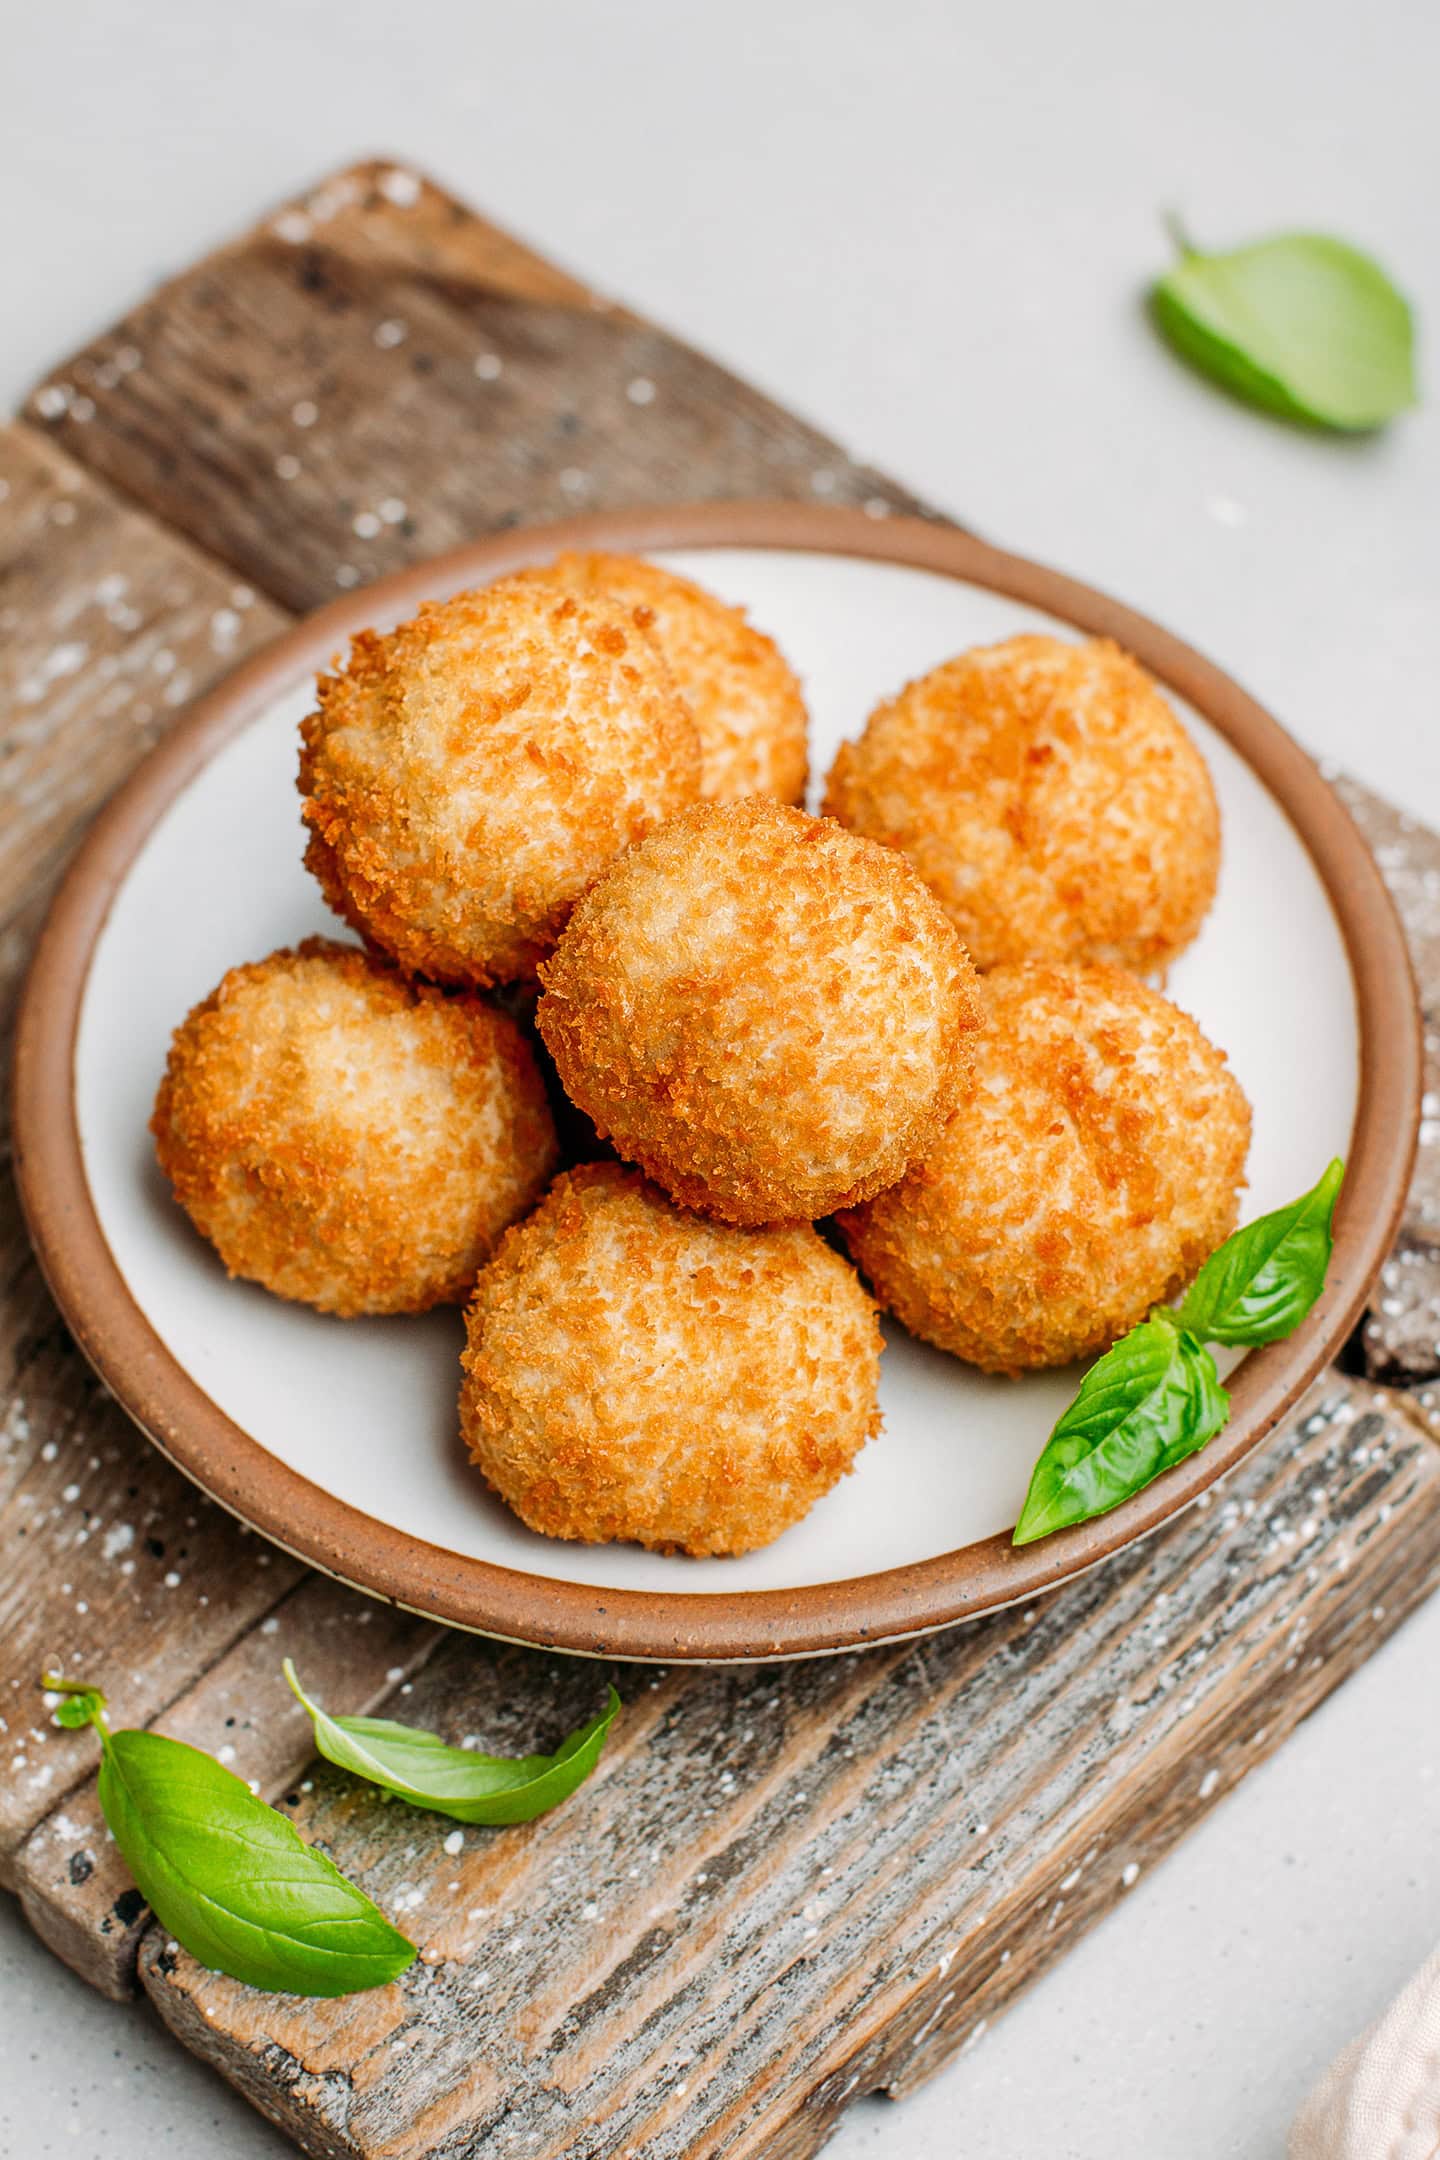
1151,233 -> 1416,430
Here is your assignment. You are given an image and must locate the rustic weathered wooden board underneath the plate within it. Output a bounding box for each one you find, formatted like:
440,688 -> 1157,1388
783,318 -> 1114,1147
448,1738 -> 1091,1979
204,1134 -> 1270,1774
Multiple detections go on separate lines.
0,162 -> 1440,2160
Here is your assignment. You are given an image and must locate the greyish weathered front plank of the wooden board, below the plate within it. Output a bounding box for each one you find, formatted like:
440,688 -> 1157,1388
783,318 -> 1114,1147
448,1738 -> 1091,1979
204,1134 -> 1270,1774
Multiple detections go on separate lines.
140,1378 -> 1440,2160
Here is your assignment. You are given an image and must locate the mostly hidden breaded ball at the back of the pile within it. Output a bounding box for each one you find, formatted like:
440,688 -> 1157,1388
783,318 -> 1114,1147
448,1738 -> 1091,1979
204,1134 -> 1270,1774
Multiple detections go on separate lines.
520,553 -> 807,804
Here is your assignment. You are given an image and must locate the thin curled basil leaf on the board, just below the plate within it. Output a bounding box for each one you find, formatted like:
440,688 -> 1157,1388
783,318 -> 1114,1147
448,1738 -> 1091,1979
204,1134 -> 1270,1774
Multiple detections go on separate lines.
285,1659 -> 620,1823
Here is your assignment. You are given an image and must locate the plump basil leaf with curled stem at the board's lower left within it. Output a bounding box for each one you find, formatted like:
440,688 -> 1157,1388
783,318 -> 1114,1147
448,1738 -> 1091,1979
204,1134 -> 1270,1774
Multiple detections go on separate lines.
45,1678 -> 415,1996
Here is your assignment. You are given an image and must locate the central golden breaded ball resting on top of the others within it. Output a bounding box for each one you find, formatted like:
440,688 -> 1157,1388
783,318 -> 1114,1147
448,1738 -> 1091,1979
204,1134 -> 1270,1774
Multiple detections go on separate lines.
535,795 -> 978,1223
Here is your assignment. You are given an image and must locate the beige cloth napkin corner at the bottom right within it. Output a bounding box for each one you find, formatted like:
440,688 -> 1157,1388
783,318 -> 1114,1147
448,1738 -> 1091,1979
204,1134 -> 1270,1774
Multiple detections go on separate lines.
1289,1950 -> 1440,2160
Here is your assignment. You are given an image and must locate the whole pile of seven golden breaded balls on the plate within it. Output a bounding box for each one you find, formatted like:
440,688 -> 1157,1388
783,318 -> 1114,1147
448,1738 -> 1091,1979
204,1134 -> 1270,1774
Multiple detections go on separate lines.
153,553 -> 1250,1553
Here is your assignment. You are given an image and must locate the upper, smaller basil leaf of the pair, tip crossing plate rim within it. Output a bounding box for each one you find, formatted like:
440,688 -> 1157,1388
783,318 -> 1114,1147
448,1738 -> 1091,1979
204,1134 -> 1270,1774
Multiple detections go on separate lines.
1179,1156 -> 1345,1344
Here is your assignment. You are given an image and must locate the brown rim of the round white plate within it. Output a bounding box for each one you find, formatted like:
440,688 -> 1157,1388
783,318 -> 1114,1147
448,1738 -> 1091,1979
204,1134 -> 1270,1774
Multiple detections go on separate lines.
13,501 -> 1421,1663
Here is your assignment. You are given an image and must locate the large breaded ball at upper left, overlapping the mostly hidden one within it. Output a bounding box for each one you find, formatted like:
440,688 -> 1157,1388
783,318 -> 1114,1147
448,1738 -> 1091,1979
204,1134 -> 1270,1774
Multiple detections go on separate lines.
300,579 -> 699,987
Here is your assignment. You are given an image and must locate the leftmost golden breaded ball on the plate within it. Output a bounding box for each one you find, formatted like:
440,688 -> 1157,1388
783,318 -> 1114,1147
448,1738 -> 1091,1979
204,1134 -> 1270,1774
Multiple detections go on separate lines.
151,937 -> 557,1318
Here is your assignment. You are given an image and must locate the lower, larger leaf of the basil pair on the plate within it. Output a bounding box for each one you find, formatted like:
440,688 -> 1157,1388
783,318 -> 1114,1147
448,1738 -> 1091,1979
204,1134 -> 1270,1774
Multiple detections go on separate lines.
1013,1309 -> 1231,1544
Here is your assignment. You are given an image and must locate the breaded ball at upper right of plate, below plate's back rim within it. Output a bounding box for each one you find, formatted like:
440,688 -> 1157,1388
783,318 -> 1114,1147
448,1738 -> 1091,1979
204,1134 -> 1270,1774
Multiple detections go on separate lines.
825,637 -> 1220,972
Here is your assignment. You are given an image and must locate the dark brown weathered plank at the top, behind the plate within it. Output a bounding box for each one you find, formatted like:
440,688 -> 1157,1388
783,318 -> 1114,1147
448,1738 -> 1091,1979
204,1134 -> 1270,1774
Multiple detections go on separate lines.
26,164 -> 920,609
